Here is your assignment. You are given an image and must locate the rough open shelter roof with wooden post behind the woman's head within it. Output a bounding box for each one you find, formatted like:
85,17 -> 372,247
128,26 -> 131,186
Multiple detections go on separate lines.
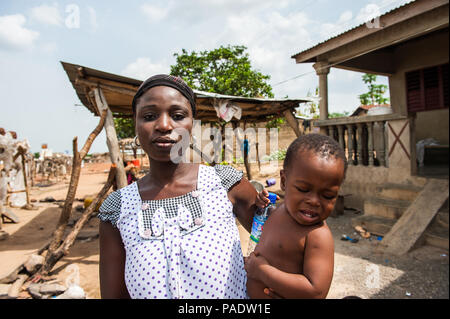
61,62 -> 312,184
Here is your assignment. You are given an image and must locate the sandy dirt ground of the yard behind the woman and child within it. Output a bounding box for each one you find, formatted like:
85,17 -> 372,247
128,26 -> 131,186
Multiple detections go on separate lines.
0,164 -> 449,299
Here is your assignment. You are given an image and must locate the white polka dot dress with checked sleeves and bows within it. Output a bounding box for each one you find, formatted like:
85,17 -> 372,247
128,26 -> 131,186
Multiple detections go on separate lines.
98,165 -> 247,299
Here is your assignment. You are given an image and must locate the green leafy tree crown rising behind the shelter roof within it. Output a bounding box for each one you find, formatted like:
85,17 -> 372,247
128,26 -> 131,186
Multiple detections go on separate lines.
170,45 -> 273,97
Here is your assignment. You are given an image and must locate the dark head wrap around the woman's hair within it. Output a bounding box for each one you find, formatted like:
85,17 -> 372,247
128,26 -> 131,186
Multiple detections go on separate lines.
132,74 -> 196,116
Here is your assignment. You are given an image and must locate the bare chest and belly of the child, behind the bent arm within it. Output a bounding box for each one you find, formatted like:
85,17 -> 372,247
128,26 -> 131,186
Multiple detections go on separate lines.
247,205 -> 323,299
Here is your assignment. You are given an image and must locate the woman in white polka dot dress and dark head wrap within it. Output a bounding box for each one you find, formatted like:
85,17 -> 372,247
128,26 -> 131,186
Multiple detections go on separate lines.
98,75 -> 257,298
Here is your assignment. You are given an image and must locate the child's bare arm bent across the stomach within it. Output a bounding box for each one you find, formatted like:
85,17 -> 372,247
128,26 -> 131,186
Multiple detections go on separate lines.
245,227 -> 334,298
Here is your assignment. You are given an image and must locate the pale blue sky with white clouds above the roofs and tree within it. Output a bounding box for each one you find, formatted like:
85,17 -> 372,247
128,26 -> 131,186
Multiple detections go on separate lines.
0,0 -> 410,154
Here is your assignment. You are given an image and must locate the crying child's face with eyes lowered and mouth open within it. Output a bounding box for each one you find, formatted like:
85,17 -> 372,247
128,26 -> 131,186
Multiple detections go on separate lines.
280,150 -> 344,225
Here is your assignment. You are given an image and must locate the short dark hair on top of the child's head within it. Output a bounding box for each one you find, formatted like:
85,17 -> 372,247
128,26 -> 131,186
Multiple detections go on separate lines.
283,133 -> 347,177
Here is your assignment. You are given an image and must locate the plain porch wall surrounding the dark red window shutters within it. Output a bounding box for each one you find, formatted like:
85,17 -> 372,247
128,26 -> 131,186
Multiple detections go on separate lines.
389,28 -> 449,144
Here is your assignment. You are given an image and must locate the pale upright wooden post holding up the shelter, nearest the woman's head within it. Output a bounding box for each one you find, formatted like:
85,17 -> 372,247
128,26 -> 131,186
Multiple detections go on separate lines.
94,88 -> 128,189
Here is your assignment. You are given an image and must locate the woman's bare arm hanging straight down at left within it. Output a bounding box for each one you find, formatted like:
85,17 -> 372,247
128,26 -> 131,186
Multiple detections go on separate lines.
99,221 -> 130,299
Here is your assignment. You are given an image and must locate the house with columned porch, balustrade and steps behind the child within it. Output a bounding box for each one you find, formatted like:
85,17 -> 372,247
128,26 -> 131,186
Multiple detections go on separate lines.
292,0 -> 449,254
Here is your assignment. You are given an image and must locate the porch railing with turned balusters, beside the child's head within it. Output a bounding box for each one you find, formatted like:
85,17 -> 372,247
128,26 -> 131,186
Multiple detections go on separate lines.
314,114 -> 405,167
